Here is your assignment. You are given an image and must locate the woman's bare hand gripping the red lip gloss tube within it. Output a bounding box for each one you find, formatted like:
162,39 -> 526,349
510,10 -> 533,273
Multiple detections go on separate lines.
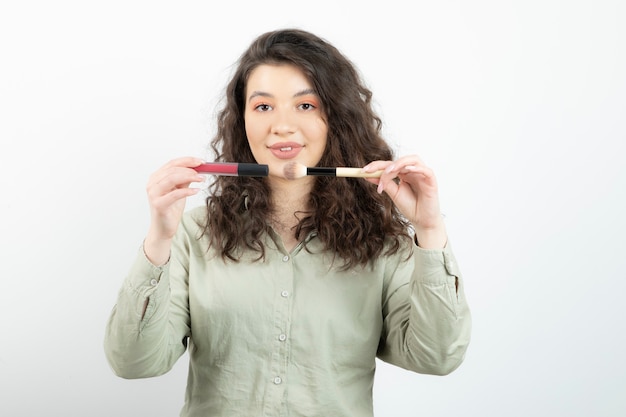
143,157 -> 204,265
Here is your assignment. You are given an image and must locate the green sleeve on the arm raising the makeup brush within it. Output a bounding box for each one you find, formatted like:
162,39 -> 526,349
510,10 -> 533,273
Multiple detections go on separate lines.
378,240 -> 471,375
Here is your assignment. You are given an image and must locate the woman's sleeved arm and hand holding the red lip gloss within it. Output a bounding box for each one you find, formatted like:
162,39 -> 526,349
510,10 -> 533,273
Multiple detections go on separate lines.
104,158 -> 202,378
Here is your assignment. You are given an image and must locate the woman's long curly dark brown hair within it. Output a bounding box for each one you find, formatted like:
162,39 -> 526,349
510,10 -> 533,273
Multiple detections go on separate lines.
204,29 -> 411,269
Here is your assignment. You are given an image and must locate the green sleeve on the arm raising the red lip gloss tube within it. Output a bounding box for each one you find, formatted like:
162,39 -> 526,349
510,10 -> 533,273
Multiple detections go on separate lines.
104,228 -> 190,378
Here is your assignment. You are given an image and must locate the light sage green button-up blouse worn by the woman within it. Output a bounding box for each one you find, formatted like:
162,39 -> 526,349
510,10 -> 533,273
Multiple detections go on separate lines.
104,207 -> 471,417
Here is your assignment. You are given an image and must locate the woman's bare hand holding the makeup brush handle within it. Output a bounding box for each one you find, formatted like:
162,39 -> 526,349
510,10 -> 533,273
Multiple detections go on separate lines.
363,155 -> 447,249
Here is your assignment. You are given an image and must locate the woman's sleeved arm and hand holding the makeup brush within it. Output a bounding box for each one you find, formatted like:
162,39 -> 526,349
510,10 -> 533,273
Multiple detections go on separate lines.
364,155 -> 471,375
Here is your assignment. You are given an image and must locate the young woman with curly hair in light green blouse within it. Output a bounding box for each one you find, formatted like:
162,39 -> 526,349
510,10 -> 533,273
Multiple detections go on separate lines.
105,30 -> 471,417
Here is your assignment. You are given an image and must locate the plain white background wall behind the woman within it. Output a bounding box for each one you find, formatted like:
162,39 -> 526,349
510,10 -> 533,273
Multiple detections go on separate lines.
0,0 -> 626,417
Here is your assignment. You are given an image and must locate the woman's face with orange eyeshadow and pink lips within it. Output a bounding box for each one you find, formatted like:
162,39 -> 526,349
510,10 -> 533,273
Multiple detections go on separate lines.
244,65 -> 328,178
